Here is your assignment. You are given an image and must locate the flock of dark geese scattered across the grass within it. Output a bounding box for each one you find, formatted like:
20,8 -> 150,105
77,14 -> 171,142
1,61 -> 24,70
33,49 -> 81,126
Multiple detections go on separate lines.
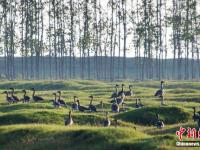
3,81 -> 200,129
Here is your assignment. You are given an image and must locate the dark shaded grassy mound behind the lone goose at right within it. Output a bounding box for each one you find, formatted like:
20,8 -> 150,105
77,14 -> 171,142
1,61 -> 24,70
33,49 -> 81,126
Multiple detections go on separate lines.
116,107 -> 190,125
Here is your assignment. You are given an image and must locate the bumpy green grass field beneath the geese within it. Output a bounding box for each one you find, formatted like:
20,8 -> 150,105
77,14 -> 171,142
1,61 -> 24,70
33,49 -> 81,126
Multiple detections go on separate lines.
0,80 -> 200,150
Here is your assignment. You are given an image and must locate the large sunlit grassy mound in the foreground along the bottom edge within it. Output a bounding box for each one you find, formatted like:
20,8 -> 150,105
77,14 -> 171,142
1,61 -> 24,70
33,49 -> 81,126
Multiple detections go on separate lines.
0,125 -> 157,150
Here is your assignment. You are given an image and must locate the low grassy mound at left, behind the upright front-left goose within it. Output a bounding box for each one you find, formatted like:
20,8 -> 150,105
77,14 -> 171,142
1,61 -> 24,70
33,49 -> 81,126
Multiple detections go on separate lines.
0,110 -> 108,125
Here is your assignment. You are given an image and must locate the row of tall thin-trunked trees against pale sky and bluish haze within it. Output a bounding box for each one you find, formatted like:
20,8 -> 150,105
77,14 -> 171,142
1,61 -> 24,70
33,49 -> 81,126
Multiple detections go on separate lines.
0,0 -> 200,81
